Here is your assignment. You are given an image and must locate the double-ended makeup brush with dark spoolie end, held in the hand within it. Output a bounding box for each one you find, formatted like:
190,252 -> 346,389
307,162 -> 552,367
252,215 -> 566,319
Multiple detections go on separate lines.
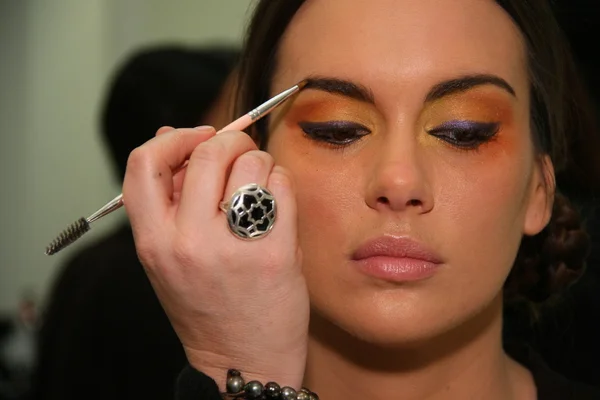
46,81 -> 306,256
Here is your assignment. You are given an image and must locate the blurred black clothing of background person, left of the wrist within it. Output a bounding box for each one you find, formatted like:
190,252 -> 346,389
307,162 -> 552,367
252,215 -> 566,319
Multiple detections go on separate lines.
32,226 -> 186,400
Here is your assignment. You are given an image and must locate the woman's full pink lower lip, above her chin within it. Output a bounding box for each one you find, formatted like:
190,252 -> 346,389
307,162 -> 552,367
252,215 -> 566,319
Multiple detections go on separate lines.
355,256 -> 439,282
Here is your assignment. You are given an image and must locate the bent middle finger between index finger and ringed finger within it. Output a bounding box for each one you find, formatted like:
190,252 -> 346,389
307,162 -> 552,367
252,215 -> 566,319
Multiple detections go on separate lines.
178,131 -> 258,230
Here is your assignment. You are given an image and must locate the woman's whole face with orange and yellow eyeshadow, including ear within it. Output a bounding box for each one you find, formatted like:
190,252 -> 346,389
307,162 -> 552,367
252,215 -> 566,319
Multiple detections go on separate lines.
268,0 -> 550,345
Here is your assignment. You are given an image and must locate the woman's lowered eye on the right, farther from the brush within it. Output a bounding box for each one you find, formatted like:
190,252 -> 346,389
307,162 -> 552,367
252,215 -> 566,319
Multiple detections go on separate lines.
427,121 -> 500,150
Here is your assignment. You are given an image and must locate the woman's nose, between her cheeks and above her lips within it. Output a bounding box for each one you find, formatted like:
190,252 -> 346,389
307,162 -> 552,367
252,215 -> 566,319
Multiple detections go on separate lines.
366,141 -> 434,214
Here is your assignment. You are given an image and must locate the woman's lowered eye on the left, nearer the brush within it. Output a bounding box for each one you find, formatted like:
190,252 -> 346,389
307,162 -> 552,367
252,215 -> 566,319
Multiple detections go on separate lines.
298,121 -> 371,148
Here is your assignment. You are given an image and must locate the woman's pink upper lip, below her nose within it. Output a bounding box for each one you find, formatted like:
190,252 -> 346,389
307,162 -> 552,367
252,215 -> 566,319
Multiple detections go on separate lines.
352,236 -> 442,264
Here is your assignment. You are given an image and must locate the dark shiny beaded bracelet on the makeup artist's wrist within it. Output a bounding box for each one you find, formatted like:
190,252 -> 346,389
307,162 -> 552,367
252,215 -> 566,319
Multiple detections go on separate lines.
221,369 -> 319,400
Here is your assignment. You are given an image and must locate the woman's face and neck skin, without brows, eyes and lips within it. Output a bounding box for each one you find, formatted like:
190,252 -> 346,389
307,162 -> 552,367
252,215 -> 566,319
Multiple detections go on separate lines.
268,0 -> 550,399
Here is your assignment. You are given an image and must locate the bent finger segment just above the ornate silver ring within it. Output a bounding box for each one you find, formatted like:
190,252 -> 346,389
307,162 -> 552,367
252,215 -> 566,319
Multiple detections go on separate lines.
223,150 -> 274,200
